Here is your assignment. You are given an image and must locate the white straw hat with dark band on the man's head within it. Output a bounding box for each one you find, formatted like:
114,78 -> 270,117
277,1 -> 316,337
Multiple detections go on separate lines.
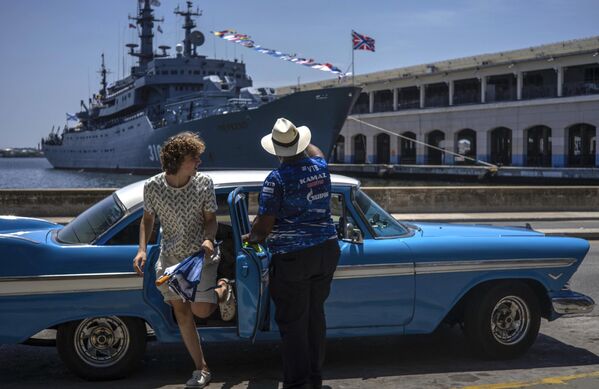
260,118 -> 312,157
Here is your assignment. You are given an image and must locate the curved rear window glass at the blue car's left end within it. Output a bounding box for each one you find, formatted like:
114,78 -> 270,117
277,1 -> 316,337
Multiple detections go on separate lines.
57,195 -> 124,244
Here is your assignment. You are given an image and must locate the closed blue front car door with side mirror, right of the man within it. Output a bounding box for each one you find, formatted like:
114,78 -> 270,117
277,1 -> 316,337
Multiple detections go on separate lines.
325,186 -> 415,329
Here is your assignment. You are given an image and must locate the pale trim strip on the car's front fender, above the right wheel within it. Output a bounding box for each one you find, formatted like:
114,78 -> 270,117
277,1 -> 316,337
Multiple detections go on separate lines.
416,258 -> 576,275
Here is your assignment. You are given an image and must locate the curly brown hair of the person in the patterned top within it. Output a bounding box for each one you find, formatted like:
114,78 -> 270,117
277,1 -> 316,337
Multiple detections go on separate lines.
160,132 -> 206,174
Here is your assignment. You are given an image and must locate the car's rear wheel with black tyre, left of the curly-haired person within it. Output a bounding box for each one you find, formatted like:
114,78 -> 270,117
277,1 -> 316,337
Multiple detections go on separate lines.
56,316 -> 146,380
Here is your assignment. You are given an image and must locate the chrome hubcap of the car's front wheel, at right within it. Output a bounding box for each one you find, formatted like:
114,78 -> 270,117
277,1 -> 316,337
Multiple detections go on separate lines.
491,296 -> 530,345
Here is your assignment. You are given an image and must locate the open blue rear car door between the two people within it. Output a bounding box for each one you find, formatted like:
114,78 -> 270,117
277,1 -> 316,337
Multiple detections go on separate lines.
227,188 -> 270,341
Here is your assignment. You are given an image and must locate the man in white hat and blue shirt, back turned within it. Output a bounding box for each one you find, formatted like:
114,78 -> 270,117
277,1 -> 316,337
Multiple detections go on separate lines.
244,118 -> 340,389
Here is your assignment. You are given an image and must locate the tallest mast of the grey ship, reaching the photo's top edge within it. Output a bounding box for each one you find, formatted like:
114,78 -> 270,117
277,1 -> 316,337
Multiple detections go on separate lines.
127,0 -> 164,72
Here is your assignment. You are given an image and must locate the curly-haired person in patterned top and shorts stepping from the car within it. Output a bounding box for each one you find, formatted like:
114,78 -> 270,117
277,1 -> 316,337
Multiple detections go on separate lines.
133,132 -> 235,388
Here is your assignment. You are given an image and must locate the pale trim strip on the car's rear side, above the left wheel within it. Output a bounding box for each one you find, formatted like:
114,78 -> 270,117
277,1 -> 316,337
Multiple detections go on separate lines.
0,272 -> 143,297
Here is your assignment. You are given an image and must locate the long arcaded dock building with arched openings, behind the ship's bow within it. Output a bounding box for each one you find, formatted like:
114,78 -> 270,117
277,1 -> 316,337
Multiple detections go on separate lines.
277,36 -> 599,168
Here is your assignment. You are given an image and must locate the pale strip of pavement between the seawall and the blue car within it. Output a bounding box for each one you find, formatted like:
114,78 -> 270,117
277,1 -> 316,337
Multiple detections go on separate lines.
46,212 -> 599,240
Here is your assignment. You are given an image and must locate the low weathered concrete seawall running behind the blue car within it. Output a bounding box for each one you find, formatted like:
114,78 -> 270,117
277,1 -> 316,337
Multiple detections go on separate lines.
0,186 -> 599,217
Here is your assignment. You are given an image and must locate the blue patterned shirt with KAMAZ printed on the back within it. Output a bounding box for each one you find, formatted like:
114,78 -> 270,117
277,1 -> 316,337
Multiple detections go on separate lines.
258,157 -> 337,254
